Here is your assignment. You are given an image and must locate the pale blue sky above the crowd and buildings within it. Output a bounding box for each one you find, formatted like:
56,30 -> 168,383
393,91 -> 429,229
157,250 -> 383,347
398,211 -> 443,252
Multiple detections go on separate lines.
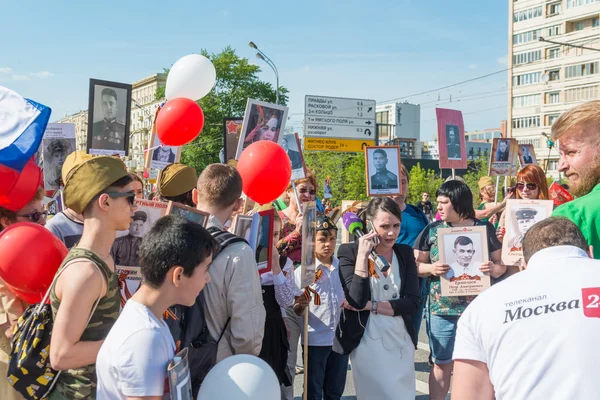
0,0 -> 508,140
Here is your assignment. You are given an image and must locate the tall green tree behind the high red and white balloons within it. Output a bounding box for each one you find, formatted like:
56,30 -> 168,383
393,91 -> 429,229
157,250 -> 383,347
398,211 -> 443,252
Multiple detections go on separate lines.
156,46 -> 288,172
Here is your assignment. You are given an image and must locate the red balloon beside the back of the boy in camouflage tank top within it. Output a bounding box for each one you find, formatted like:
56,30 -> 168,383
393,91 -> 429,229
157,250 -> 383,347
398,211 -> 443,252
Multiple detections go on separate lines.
0,222 -> 68,300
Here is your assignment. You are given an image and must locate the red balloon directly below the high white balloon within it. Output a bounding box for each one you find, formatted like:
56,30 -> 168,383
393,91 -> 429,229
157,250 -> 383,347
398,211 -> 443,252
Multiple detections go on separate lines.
156,97 -> 204,146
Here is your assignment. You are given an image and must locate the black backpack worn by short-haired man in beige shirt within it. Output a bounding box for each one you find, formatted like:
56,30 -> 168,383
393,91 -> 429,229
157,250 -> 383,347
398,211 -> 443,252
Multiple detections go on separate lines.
164,227 -> 248,393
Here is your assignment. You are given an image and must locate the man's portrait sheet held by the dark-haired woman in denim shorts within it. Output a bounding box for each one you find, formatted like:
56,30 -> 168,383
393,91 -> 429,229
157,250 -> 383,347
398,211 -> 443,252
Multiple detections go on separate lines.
438,226 -> 490,296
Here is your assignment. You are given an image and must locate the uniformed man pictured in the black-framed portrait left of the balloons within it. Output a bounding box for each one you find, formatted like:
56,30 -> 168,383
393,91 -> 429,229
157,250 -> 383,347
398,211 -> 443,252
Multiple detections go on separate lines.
92,88 -> 125,150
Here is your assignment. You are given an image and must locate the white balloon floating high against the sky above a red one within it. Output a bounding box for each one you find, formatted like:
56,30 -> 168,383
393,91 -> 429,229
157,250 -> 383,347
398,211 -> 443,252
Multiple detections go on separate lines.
165,54 -> 217,101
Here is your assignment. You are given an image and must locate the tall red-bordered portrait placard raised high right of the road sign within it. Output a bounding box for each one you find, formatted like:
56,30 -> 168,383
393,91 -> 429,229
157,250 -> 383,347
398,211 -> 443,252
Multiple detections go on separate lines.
435,108 -> 467,169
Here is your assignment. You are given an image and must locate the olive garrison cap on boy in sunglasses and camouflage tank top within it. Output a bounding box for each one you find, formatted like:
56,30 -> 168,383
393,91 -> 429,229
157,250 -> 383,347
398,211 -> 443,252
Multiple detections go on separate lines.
63,156 -> 127,214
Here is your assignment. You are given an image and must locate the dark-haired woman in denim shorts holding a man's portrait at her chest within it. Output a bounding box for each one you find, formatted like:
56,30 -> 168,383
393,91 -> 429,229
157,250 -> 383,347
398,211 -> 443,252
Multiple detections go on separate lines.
414,181 -> 506,400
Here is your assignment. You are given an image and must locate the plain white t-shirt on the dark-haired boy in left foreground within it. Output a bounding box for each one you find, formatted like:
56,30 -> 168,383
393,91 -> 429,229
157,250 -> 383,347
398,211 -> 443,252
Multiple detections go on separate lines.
96,299 -> 175,400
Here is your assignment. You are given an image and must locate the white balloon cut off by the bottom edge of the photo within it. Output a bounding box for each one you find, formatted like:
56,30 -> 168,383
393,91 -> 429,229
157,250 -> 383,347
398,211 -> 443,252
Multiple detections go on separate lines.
198,354 -> 281,400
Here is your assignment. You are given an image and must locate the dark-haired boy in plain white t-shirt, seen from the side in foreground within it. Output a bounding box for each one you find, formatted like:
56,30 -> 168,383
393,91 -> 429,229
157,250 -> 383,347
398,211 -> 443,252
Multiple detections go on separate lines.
96,215 -> 219,400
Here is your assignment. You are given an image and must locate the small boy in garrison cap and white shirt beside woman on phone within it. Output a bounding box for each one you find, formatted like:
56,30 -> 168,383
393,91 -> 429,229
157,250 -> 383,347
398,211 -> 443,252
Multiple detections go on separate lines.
294,214 -> 348,400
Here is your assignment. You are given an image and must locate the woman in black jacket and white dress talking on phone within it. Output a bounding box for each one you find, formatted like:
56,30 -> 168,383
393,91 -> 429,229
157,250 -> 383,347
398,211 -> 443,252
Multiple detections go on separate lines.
333,197 -> 420,399
